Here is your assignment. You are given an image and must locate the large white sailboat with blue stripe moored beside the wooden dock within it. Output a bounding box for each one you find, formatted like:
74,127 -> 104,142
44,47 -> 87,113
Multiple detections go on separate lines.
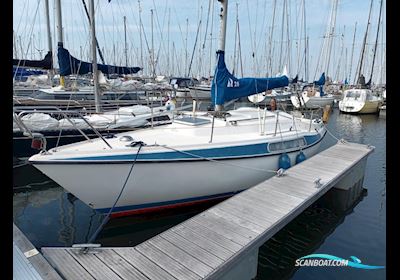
29,0 -> 326,216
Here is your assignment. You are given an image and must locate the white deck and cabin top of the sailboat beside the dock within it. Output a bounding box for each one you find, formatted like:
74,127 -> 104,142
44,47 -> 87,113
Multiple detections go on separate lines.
36,108 -> 315,156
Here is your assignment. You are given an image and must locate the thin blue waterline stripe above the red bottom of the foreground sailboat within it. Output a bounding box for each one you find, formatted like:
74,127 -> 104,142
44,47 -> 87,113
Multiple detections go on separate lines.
96,190 -> 243,213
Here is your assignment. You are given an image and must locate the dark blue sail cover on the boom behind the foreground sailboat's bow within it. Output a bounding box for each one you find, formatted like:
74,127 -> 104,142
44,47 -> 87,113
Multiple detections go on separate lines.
57,47 -> 142,76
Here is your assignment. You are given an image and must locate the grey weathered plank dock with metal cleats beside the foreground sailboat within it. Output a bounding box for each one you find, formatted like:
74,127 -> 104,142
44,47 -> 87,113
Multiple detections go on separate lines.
42,142 -> 374,279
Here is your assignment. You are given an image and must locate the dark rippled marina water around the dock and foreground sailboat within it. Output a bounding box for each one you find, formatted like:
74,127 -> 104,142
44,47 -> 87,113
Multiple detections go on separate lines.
13,109 -> 386,279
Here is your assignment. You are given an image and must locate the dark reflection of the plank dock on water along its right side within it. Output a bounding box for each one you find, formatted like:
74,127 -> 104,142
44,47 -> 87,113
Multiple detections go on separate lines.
255,179 -> 367,280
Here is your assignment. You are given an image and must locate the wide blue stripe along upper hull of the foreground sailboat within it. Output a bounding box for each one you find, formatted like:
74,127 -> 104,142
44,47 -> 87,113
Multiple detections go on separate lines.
55,134 -> 323,162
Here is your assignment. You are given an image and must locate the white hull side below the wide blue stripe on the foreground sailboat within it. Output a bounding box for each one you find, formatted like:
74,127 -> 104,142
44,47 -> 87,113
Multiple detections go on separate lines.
34,142 -> 320,216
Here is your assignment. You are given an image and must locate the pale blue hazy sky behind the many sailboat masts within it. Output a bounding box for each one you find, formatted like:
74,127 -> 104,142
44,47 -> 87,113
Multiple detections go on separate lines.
13,0 -> 386,82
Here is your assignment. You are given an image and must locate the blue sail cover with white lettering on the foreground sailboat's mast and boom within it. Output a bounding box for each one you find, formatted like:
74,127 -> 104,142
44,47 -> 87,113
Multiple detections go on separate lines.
211,51 -> 289,105
